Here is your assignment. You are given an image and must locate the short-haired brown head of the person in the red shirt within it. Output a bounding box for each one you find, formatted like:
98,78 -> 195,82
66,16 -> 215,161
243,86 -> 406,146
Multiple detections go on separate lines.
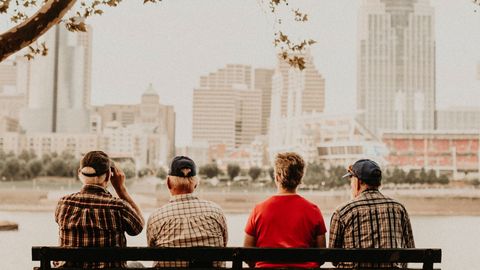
275,152 -> 305,190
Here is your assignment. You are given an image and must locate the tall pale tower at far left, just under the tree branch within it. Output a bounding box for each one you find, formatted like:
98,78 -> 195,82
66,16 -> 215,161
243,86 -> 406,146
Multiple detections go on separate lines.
20,26 -> 92,133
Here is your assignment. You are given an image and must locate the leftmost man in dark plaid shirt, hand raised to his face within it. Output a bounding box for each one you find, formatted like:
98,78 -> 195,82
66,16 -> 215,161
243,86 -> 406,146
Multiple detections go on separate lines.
55,151 -> 144,268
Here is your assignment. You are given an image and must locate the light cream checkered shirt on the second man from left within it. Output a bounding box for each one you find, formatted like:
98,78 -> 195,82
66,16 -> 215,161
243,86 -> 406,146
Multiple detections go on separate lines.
147,194 -> 228,267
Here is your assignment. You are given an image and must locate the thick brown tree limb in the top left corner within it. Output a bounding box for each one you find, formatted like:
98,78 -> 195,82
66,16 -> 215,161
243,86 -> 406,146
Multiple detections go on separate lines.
0,0 -> 76,62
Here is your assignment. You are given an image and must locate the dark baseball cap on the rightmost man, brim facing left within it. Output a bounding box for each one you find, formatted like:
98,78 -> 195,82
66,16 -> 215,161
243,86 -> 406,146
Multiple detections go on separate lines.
342,159 -> 382,185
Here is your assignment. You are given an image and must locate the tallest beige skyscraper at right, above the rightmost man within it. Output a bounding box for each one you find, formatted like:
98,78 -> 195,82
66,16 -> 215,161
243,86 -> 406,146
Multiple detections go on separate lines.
357,0 -> 435,133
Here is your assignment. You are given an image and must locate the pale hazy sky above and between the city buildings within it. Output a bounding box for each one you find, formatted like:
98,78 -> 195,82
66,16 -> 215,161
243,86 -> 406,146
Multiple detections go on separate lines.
10,0 -> 480,145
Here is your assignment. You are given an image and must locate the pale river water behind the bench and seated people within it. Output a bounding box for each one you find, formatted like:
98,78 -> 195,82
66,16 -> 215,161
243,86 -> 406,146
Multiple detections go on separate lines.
0,211 -> 480,270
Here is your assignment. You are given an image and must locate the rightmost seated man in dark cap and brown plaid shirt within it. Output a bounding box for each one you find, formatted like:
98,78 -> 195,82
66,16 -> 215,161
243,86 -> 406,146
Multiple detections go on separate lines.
329,159 -> 415,268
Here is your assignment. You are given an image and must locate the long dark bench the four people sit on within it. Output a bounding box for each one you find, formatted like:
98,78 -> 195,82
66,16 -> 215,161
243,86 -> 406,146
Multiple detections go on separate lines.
32,247 -> 442,270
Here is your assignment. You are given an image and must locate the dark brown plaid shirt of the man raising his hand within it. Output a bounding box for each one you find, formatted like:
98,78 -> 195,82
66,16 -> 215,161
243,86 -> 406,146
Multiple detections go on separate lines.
55,185 -> 143,268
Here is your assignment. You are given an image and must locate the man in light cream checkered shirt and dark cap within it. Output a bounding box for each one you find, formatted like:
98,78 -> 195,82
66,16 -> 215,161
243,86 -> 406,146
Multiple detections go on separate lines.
147,156 -> 227,267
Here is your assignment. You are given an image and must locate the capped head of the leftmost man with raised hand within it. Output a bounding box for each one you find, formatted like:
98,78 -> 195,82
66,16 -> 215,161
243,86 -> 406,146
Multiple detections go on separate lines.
79,151 -> 112,183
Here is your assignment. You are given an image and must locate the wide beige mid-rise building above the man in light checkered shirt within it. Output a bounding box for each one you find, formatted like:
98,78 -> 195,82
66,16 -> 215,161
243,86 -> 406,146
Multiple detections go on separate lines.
192,65 -> 262,151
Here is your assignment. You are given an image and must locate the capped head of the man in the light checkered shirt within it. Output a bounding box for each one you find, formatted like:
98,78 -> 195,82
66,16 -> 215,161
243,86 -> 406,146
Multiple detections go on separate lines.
168,156 -> 197,193
